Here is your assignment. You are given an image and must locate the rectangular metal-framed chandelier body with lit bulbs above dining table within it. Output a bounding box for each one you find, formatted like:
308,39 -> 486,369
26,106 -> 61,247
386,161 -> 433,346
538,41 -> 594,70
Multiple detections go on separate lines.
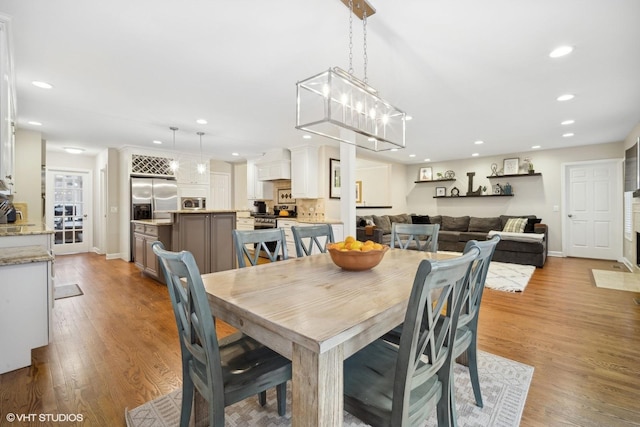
296,67 -> 406,151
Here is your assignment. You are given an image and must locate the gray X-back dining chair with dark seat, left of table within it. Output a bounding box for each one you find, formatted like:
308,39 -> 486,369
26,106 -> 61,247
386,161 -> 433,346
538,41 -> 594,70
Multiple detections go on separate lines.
151,241 -> 291,427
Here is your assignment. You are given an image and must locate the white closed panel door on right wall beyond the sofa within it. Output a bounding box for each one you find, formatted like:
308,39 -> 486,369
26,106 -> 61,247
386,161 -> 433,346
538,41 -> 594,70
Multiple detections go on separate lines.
563,160 -> 623,260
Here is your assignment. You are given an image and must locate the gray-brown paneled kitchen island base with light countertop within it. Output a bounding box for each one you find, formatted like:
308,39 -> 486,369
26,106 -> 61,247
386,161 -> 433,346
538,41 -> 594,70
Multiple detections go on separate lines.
171,210 -> 236,274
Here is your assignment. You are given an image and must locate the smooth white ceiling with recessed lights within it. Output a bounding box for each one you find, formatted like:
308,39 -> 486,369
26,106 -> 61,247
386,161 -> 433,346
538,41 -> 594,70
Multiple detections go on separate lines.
0,0 -> 640,164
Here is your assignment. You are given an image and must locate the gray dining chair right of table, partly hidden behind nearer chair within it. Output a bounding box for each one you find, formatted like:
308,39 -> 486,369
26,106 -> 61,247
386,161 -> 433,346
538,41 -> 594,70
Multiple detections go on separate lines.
444,235 -> 500,425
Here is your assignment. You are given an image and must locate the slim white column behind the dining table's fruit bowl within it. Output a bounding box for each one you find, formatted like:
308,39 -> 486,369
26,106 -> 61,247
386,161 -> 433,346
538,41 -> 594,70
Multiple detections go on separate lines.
340,130 -> 356,237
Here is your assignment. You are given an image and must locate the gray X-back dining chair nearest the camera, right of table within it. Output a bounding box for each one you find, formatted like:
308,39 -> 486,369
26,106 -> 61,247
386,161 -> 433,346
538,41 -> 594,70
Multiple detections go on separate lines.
344,249 -> 479,426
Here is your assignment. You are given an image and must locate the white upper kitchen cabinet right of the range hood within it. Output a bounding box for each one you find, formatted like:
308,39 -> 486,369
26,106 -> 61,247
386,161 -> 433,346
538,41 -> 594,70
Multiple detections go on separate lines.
291,145 -> 321,199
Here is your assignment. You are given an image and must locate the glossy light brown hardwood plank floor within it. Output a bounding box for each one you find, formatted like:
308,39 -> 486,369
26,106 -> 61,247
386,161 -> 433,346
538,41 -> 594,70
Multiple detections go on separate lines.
0,254 -> 640,426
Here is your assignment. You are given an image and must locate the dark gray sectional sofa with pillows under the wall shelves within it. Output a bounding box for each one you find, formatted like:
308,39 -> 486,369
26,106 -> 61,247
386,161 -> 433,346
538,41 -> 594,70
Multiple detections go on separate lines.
356,214 -> 548,267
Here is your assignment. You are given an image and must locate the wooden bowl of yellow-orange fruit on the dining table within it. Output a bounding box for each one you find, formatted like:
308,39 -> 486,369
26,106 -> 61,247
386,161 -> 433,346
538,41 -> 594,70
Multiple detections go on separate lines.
327,236 -> 389,271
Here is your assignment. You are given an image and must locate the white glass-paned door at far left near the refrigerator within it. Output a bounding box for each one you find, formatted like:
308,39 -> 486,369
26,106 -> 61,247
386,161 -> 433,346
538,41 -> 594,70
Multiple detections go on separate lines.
46,170 -> 93,255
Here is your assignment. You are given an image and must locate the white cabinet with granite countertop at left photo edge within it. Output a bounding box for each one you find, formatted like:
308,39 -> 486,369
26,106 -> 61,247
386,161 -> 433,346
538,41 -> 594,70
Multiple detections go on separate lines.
0,224 -> 54,374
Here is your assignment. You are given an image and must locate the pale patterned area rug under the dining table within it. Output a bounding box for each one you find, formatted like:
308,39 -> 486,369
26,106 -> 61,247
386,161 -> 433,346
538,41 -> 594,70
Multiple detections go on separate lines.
125,351 -> 533,427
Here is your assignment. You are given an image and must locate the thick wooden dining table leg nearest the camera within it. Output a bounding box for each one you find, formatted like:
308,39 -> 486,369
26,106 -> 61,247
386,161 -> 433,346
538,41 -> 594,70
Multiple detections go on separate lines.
291,344 -> 344,427
